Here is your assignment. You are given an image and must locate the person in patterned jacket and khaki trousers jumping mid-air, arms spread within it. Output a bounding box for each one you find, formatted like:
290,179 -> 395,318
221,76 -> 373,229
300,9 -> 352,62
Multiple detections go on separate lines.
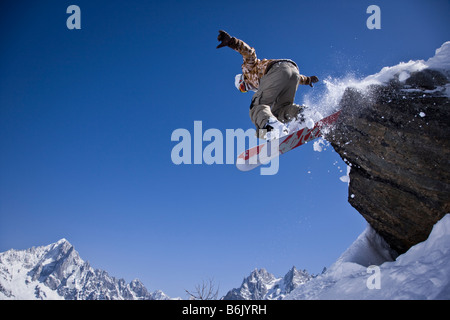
217,30 -> 319,138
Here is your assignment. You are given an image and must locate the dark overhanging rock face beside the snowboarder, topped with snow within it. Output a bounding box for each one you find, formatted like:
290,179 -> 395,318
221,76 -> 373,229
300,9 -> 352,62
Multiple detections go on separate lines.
326,70 -> 450,254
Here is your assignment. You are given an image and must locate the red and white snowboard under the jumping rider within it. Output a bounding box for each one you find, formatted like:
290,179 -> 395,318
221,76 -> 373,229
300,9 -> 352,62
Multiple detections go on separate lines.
236,110 -> 341,171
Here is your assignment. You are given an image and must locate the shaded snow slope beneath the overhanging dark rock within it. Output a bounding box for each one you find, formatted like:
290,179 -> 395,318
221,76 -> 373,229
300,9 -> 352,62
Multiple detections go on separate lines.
285,214 -> 450,300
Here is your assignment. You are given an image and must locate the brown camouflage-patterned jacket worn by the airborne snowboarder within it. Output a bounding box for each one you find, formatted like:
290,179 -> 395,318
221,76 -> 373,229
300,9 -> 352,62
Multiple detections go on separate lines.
228,37 -> 311,89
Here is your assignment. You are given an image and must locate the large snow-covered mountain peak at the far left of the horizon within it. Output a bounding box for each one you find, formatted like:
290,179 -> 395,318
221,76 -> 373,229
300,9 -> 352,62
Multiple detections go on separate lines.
0,239 -> 168,300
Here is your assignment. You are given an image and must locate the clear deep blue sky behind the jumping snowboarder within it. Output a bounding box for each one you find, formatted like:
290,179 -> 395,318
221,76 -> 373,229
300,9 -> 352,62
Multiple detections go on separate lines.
0,0 -> 450,298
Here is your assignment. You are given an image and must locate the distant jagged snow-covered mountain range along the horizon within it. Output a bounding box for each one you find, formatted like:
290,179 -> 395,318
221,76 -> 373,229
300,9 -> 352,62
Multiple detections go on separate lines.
0,239 -> 314,300
